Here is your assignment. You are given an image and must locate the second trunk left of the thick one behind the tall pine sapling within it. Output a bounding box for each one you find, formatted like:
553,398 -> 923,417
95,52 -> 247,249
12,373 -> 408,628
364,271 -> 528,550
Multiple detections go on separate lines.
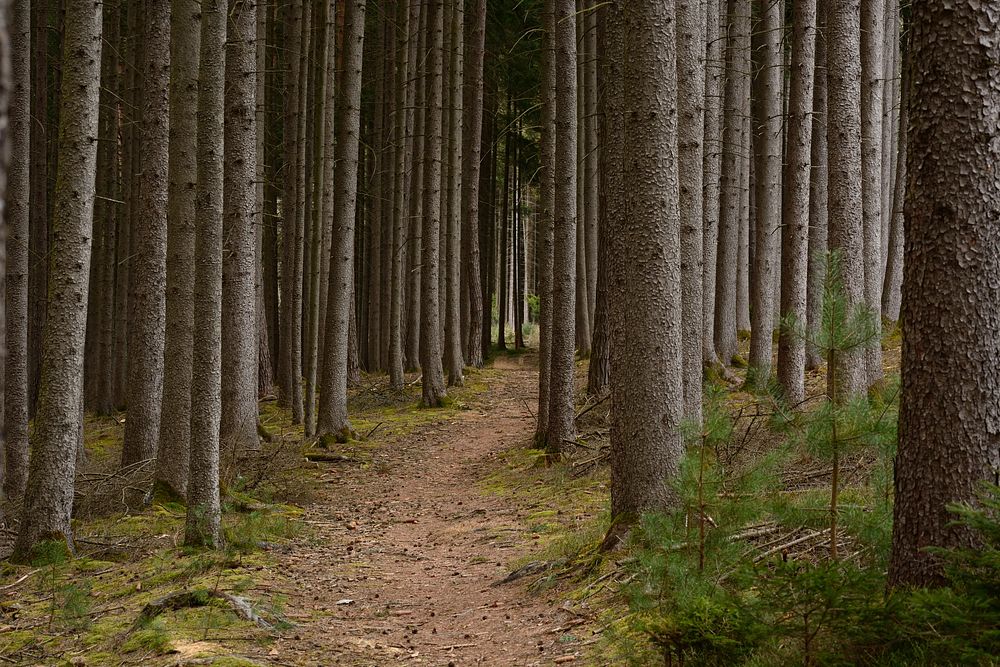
778,0 -> 817,405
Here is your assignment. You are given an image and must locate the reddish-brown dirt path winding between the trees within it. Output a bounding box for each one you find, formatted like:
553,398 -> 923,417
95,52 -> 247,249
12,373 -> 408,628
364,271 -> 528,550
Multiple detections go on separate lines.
250,358 -> 584,665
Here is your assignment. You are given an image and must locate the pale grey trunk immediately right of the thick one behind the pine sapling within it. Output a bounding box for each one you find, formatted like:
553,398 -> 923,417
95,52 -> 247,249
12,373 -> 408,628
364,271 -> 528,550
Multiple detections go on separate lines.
861,0 -> 886,386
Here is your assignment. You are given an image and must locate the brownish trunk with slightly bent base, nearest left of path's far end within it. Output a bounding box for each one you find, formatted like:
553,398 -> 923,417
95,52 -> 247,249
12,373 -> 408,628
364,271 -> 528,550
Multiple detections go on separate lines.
461,0 -> 486,368
